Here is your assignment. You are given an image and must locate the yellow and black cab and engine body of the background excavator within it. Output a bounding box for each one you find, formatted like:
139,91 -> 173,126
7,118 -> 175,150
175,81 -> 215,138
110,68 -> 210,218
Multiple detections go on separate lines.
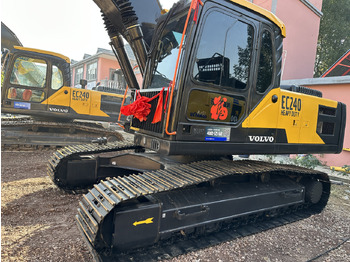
1,46 -> 124,122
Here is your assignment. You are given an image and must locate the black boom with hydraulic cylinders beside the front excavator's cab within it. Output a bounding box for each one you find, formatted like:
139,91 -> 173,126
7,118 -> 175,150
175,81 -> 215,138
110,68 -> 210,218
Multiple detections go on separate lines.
94,0 -> 161,89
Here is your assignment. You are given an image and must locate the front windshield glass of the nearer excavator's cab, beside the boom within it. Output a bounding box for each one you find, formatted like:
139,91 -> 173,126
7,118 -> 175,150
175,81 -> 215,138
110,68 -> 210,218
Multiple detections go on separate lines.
148,13 -> 187,88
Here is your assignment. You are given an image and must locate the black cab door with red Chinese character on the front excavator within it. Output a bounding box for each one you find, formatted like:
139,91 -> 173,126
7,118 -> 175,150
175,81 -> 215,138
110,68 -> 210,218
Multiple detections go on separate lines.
177,2 -> 258,143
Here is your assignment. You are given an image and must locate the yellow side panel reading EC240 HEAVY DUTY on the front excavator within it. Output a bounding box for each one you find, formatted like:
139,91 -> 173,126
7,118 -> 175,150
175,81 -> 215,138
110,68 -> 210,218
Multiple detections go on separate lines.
242,88 -> 337,144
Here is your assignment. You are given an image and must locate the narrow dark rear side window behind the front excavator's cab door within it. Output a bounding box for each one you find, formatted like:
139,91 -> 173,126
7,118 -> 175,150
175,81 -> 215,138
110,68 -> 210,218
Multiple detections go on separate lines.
256,30 -> 273,93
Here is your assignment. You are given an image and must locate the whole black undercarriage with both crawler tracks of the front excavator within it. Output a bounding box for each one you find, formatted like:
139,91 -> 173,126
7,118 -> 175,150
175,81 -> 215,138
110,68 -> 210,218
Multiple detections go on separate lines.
48,142 -> 330,256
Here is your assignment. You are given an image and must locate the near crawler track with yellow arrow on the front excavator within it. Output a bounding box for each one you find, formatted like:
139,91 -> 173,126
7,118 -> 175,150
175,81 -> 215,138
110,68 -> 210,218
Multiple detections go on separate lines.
76,154 -> 330,252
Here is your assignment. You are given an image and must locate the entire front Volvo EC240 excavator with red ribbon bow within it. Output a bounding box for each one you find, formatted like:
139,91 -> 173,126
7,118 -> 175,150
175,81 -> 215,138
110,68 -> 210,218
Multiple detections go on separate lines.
48,0 -> 346,258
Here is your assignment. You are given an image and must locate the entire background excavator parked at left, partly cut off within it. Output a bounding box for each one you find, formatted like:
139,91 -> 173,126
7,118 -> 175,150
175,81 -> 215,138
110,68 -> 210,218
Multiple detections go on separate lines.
1,23 -> 129,146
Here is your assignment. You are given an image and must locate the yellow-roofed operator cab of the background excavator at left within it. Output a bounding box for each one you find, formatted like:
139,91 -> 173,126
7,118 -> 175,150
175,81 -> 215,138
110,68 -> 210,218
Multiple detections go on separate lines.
1,46 -> 70,114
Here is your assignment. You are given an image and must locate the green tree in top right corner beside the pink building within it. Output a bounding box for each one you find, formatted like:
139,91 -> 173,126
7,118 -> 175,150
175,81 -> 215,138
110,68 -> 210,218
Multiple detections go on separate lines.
314,0 -> 350,77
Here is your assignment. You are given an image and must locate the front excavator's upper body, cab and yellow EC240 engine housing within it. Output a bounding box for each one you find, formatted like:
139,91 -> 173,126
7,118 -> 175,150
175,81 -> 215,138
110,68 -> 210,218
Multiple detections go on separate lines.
131,0 -> 345,155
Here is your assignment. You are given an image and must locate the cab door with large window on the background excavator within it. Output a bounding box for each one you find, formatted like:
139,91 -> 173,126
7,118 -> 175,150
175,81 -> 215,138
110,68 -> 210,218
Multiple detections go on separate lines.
2,54 -> 50,115
